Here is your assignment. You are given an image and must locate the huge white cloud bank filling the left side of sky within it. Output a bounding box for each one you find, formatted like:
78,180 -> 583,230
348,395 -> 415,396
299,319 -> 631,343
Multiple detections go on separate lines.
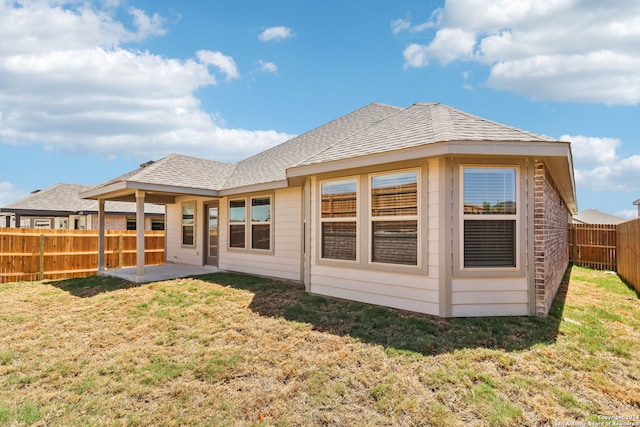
0,0 -> 290,161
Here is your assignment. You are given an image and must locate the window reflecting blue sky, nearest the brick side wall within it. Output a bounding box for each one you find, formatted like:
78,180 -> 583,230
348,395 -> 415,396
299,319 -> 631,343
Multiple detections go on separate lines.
462,167 -> 518,268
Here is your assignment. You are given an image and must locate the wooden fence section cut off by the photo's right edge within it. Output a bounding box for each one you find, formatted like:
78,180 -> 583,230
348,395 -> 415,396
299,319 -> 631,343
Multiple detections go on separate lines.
617,219 -> 640,292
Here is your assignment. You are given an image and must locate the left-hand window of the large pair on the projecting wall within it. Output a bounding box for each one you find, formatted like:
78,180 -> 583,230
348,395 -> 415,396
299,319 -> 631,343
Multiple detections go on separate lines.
320,178 -> 358,261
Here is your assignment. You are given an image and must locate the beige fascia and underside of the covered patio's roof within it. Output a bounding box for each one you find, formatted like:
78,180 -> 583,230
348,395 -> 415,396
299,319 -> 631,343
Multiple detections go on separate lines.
80,181 -> 219,205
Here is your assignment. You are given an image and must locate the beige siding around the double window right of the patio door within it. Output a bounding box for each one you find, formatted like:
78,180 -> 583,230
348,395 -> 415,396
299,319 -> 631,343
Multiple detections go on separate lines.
219,187 -> 302,281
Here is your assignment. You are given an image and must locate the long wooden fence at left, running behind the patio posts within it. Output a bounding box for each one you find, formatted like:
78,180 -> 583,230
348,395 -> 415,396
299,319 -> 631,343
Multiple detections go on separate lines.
0,228 -> 165,283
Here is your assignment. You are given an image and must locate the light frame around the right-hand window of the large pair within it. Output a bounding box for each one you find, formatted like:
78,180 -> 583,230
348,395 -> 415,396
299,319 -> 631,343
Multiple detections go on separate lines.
367,168 -> 422,270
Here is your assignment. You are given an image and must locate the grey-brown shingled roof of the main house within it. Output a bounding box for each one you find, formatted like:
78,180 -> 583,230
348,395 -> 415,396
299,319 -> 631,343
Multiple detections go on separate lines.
81,103 -> 576,205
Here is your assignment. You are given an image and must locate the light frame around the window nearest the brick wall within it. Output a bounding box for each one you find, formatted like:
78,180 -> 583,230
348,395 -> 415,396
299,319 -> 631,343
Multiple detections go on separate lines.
458,164 -> 523,272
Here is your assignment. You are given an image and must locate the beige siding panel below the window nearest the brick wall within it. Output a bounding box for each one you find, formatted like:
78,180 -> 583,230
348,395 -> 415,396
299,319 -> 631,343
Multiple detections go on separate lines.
451,277 -> 529,317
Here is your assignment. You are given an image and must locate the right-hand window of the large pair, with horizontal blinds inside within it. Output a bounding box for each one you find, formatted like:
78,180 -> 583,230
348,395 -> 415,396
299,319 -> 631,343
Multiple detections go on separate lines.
370,170 -> 418,265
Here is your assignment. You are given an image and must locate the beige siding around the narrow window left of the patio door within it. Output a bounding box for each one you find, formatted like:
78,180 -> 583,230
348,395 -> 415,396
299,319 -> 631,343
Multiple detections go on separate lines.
165,196 -> 205,265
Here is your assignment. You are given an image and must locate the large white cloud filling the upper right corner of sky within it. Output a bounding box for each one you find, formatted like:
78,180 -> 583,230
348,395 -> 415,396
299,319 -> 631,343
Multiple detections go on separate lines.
400,0 -> 640,105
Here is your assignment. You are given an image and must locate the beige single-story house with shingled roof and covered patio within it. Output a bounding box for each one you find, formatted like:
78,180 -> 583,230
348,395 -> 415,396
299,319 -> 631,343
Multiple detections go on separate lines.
81,103 -> 577,317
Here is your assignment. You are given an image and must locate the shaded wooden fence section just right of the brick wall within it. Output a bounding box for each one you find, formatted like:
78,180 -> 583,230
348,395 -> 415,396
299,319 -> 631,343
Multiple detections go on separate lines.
569,224 -> 617,271
